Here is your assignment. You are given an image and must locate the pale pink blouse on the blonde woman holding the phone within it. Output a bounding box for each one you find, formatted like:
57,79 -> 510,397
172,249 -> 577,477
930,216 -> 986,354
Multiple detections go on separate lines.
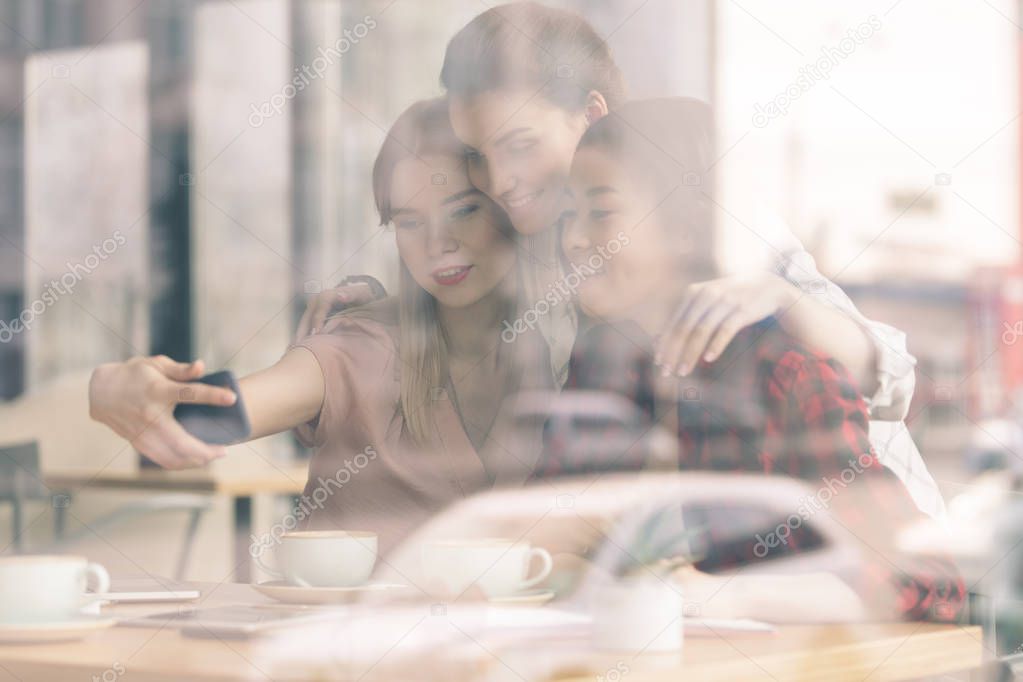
295,299 -> 552,553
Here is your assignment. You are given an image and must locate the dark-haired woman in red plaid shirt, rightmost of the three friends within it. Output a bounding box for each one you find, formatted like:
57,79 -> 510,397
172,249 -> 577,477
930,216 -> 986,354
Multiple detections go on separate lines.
536,99 -> 965,621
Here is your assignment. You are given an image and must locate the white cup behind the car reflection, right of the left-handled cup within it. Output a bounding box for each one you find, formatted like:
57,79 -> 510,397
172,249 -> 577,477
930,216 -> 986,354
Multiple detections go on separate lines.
422,538 -> 553,598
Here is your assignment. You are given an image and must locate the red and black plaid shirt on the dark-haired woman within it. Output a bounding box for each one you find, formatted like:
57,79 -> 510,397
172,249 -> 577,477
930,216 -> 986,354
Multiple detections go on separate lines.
536,319 -> 966,621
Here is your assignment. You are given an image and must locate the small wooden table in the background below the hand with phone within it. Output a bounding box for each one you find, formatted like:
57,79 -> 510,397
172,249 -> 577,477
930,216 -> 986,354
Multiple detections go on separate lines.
45,462 -> 309,583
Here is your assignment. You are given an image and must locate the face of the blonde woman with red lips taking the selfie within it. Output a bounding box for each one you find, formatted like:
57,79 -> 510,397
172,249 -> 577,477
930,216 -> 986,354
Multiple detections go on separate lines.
391,155 -> 516,308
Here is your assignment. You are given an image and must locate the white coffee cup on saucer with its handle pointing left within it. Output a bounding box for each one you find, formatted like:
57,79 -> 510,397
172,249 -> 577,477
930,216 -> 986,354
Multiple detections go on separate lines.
253,531 -> 376,587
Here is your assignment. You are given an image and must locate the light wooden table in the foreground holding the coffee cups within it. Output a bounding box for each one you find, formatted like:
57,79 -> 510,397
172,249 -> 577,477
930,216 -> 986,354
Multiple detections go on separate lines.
0,584 -> 982,682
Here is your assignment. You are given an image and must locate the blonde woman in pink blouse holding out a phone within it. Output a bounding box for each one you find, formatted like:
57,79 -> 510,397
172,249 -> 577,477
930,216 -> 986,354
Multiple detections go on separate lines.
90,100 -> 550,551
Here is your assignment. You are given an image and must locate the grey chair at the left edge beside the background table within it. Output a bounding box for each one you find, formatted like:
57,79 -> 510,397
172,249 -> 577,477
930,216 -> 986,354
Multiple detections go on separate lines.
0,441 -> 212,580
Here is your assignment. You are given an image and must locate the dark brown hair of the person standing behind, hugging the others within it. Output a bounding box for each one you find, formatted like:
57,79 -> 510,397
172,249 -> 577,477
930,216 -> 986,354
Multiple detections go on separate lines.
441,2 -> 625,111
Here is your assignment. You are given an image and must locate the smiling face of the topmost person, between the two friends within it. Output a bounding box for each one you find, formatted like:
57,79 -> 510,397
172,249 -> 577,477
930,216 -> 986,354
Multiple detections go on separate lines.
450,89 -> 593,234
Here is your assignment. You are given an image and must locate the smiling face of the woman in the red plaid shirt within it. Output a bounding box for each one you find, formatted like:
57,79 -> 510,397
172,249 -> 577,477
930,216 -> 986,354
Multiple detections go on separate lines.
559,147 -> 681,321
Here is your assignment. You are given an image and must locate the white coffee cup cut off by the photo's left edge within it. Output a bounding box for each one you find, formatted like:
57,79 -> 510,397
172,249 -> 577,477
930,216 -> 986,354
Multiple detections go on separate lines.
0,554 -> 110,624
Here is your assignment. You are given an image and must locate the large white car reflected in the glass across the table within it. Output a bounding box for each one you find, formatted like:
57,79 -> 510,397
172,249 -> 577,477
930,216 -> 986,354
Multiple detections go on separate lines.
381,471 -> 863,618
